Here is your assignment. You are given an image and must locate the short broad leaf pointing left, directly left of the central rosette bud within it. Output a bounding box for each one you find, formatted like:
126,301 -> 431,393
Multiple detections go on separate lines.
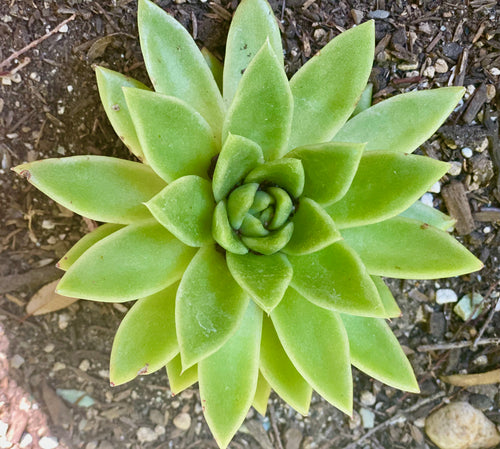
146,175 -> 215,246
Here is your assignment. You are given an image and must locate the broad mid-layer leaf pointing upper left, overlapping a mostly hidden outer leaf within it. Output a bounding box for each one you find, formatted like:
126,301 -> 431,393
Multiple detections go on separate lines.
123,88 -> 217,182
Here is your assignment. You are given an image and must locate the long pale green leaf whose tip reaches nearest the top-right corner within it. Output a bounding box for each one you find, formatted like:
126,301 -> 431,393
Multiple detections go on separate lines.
288,20 -> 375,150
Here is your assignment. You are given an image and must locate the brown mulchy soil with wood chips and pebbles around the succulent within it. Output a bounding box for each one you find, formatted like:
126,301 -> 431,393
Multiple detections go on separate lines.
0,0 -> 500,449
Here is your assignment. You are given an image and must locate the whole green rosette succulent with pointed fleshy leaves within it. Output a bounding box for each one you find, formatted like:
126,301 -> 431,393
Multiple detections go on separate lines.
15,0 -> 482,447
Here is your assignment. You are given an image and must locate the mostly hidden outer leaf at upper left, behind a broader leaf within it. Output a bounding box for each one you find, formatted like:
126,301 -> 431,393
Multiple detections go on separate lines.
95,66 -> 149,161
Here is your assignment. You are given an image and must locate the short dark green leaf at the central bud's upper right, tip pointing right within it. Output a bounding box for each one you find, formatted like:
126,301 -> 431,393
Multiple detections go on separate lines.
287,142 -> 365,206
